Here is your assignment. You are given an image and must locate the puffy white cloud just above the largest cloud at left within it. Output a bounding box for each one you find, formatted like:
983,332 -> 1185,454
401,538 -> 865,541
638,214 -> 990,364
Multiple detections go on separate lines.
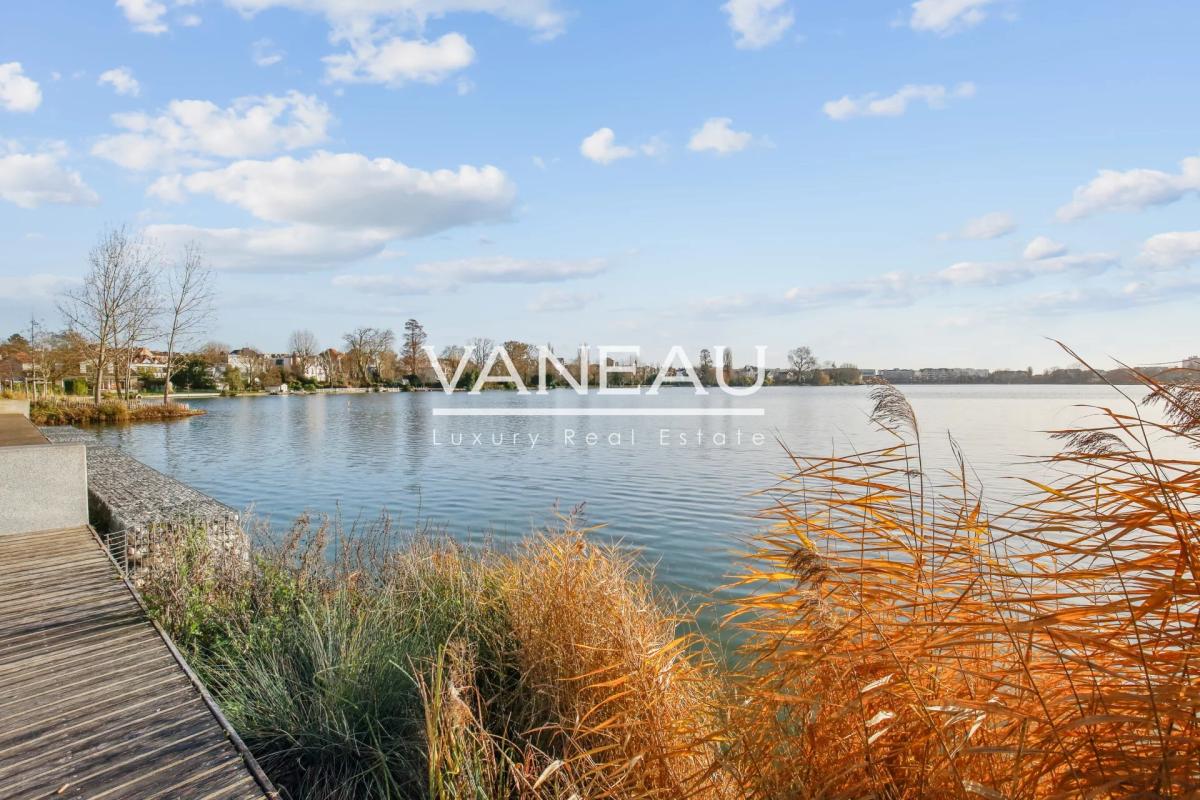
91,91 -> 332,170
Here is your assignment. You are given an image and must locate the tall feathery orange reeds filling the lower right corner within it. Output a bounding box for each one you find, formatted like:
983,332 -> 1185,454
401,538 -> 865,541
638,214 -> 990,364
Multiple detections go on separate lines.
731,357 -> 1200,799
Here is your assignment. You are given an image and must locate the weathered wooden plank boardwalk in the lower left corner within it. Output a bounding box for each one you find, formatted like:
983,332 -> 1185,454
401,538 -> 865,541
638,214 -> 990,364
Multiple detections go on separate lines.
0,528 -> 275,800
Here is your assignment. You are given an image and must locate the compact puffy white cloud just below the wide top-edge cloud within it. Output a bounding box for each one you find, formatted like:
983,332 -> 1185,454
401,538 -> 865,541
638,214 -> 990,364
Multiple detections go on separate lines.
323,34 -> 475,86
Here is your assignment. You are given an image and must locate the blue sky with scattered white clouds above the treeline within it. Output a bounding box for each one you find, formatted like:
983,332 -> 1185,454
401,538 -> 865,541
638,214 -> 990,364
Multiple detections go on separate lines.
0,0 -> 1200,368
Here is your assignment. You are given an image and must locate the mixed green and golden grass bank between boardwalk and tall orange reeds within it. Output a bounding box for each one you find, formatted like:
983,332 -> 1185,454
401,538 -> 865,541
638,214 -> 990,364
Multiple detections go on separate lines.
144,521 -> 737,799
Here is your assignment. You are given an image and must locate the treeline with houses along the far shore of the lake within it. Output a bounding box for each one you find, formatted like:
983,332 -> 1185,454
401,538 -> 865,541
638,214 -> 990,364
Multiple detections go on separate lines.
0,228 -> 1194,404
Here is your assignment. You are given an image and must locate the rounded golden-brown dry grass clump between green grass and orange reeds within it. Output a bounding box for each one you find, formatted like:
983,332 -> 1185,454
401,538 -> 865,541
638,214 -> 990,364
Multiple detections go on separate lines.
504,529 -> 739,799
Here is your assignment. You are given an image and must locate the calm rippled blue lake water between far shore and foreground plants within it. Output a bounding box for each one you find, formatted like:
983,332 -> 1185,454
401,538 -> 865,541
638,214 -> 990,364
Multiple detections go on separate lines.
100,386 -> 1140,599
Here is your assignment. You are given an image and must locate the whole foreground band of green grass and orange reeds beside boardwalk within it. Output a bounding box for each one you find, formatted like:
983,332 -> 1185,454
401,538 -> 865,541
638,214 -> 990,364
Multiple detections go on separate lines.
131,367 -> 1200,800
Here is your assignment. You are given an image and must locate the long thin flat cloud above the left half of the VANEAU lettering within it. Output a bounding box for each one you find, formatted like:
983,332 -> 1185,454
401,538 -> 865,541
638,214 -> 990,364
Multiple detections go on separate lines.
334,255 -> 608,295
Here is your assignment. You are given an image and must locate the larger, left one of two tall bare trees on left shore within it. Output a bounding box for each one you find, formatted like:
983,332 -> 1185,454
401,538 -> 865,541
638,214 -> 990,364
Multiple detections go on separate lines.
59,228 -> 157,403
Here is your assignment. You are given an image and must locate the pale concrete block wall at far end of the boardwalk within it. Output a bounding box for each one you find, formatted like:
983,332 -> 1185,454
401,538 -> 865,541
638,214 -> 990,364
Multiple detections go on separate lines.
0,444 -> 88,535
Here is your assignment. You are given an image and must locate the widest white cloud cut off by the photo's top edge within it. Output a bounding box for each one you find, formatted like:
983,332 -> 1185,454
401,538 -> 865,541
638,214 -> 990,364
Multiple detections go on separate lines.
224,0 -> 566,38
